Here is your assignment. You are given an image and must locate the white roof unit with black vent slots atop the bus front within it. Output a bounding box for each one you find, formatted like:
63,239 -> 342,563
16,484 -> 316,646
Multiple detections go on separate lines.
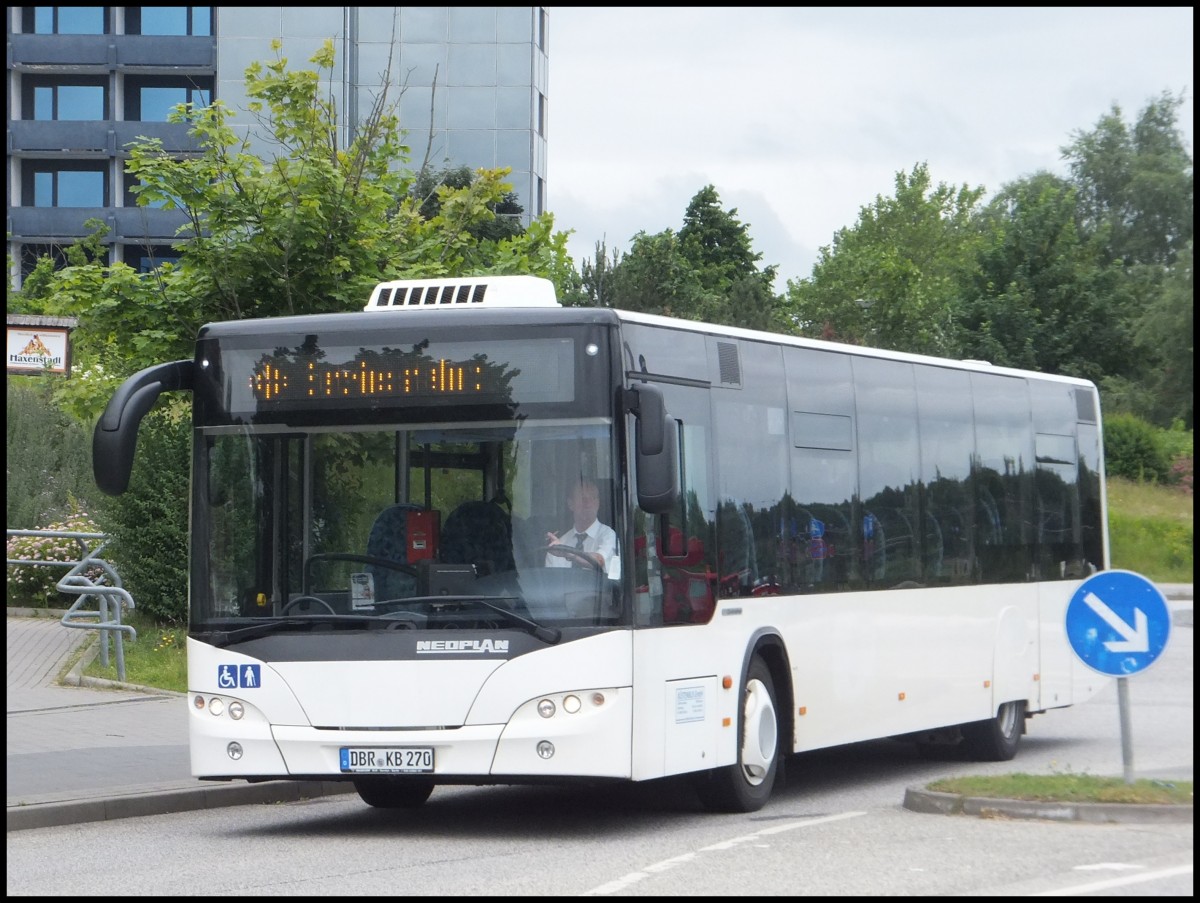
364,276 -> 560,311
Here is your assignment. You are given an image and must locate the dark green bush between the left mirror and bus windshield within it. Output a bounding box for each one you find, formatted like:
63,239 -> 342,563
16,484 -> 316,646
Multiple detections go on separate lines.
102,405 -> 191,624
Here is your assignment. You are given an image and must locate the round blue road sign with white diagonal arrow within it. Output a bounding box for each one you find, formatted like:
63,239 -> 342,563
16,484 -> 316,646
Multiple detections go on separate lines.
1067,570 -> 1171,677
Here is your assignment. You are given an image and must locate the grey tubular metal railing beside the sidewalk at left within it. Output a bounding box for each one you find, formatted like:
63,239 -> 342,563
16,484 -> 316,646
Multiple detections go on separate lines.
7,530 -> 138,681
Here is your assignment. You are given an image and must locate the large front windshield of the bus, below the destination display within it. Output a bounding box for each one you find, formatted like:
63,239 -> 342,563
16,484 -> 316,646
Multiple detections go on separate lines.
191,423 -> 622,630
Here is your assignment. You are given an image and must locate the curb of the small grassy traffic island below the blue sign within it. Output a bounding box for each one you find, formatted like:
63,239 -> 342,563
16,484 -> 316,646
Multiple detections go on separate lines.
904,787 -> 1193,825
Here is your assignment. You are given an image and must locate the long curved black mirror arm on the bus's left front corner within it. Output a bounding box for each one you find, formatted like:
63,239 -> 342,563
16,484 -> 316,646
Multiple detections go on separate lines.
91,360 -> 193,496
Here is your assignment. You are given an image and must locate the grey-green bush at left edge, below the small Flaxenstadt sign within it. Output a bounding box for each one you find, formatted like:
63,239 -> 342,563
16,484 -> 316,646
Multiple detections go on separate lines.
5,376 -> 97,528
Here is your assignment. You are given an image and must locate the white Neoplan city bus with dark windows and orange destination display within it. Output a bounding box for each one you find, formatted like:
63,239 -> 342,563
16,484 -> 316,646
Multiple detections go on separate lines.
94,276 -> 1109,812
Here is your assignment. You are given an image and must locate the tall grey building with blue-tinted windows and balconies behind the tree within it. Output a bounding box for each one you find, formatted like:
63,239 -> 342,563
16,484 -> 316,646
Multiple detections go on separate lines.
8,6 -> 547,283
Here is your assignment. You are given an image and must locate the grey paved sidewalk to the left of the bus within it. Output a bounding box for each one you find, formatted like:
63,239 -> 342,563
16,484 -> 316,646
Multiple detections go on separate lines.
6,585 -> 1192,831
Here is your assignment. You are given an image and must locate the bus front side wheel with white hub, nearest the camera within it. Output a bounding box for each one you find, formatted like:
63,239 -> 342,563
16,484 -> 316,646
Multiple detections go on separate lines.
695,657 -> 779,812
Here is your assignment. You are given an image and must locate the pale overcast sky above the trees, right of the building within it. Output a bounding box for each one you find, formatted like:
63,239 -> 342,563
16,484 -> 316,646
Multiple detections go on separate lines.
547,6 -> 1194,291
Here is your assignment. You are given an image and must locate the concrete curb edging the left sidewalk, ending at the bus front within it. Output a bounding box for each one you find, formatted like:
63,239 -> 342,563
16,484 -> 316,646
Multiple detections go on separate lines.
7,781 -> 354,831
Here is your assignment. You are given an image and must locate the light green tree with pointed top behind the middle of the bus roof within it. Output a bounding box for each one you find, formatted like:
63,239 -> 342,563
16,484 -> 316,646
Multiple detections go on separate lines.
787,163 -> 983,357
